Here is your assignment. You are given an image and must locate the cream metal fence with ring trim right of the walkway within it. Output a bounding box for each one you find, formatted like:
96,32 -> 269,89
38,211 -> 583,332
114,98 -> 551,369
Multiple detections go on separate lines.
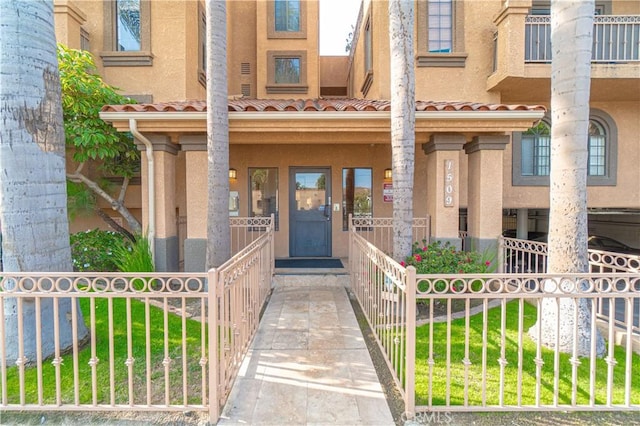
349,227 -> 640,415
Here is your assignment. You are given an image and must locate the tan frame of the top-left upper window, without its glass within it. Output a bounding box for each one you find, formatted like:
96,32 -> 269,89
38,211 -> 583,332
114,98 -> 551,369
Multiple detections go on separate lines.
100,0 -> 153,67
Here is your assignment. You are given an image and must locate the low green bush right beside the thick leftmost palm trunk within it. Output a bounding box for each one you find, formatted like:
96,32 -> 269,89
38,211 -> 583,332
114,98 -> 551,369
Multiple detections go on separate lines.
71,229 -> 127,272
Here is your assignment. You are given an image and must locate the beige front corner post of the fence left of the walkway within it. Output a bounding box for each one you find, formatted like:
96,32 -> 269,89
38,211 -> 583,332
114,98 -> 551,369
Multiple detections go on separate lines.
207,268 -> 220,424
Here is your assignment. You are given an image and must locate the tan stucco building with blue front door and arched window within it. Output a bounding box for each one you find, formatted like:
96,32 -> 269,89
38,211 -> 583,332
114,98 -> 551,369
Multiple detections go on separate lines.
55,0 -> 640,271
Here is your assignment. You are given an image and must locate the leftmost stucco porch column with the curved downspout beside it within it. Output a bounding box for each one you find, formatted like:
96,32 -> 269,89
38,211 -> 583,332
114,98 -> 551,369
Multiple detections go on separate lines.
138,134 -> 179,272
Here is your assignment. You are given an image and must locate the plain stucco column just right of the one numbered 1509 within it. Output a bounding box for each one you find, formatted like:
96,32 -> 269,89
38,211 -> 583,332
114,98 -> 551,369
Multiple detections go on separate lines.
464,135 -> 509,251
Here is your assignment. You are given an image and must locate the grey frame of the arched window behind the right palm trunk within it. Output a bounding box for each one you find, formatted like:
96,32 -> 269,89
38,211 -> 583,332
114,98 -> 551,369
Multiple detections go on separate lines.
511,109 -> 618,186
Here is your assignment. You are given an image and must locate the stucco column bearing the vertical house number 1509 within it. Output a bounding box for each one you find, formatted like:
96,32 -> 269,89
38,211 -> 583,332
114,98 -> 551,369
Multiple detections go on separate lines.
422,134 -> 465,249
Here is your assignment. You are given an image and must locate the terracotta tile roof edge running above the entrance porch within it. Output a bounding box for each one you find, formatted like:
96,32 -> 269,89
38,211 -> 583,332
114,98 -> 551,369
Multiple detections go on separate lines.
102,98 -> 545,112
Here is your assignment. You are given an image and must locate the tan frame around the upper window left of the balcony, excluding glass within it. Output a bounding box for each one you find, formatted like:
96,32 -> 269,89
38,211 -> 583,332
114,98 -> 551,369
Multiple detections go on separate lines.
416,0 -> 467,67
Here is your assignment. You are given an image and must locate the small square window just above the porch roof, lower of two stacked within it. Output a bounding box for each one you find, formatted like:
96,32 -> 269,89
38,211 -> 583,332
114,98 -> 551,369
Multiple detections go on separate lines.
267,51 -> 309,93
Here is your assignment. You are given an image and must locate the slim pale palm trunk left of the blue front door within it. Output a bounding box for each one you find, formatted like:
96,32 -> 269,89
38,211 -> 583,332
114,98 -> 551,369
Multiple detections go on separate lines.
206,0 -> 231,268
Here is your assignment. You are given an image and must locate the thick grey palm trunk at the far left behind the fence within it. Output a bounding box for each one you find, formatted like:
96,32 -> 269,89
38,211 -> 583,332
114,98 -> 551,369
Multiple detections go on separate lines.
0,0 -> 87,363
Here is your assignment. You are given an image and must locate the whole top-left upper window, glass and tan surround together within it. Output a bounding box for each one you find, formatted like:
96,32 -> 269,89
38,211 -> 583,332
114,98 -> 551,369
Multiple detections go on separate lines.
101,0 -> 153,66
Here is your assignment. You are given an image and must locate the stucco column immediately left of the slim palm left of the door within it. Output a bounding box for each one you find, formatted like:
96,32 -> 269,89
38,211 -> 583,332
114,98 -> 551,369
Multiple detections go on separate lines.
180,135 -> 208,272
